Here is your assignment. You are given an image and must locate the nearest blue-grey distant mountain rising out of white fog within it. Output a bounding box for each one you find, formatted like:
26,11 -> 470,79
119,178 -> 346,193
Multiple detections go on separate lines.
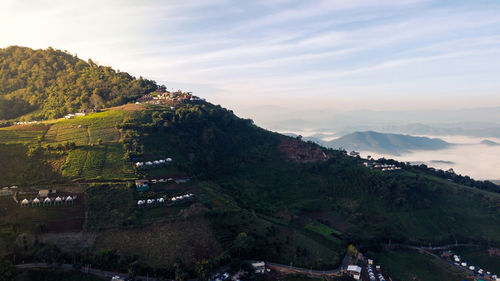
322,131 -> 453,155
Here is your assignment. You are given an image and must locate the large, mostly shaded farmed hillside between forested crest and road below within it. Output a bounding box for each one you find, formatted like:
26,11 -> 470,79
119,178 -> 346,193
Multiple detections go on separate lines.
0,47 -> 500,280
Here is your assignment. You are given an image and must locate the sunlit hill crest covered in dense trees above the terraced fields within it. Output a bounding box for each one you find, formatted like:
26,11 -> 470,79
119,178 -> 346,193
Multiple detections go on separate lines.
0,46 -> 158,120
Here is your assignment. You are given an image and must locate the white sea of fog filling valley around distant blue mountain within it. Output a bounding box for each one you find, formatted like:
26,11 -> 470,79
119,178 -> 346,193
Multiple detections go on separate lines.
282,131 -> 500,180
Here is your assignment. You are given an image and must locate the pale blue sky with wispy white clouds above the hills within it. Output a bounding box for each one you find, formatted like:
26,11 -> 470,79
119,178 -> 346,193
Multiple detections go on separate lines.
0,0 -> 500,117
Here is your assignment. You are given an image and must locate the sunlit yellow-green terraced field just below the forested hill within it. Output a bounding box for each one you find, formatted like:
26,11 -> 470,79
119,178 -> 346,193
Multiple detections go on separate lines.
0,111 -> 135,186
